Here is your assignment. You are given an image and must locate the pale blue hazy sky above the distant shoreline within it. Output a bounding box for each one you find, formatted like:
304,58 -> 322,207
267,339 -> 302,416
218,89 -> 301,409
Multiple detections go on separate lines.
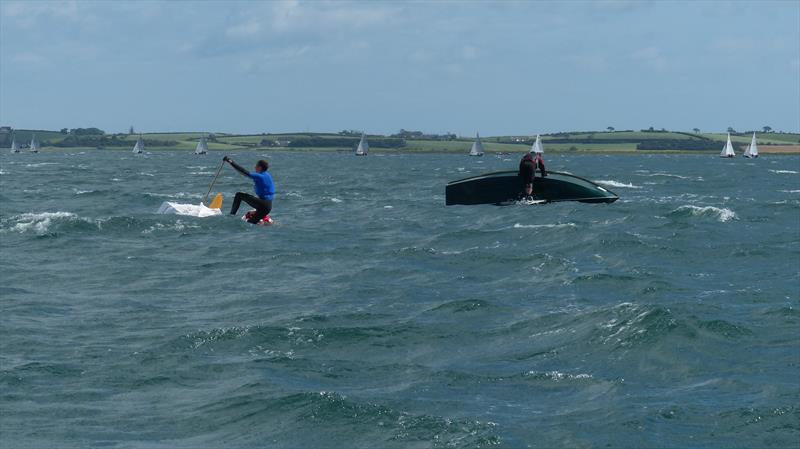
0,0 -> 800,136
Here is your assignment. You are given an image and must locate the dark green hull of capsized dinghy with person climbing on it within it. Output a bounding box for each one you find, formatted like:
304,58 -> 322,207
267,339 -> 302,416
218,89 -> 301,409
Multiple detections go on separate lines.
445,171 -> 619,206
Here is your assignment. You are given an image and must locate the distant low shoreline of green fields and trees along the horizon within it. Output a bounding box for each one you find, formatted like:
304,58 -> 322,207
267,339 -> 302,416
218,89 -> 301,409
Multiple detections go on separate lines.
0,126 -> 800,155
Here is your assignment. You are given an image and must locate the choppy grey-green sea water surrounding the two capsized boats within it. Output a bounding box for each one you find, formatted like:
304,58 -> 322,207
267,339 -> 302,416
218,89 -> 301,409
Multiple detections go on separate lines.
0,151 -> 800,448
